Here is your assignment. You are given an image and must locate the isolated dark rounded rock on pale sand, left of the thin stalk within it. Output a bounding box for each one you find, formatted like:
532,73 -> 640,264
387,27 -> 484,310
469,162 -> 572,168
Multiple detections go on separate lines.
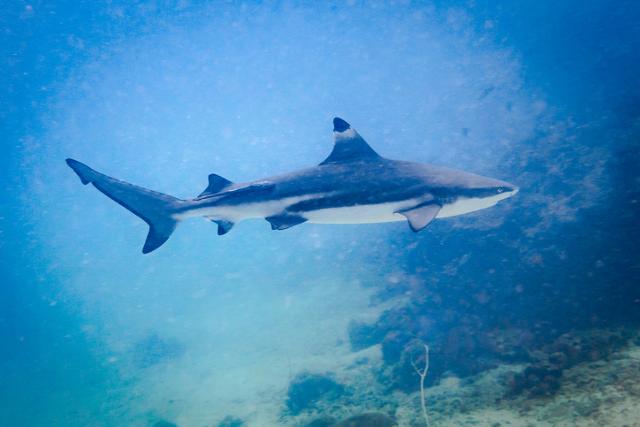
286,373 -> 346,415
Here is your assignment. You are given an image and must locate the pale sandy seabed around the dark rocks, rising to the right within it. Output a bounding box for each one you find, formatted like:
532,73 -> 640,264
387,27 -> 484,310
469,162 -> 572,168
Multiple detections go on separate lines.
125,325 -> 640,427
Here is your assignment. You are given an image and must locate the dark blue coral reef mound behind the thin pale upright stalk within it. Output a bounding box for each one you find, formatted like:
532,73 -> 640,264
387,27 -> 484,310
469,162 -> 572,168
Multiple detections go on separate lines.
348,284 -> 626,402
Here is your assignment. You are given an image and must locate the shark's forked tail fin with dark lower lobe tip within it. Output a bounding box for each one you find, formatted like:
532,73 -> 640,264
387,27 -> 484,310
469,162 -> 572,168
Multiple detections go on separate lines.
67,159 -> 181,254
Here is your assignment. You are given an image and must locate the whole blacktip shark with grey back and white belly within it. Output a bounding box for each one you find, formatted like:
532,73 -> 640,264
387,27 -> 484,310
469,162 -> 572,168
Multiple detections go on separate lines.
66,117 -> 519,254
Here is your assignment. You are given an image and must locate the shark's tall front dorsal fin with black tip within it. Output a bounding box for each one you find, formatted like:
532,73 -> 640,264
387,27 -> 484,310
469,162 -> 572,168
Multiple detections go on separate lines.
320,117 -> 380,165
